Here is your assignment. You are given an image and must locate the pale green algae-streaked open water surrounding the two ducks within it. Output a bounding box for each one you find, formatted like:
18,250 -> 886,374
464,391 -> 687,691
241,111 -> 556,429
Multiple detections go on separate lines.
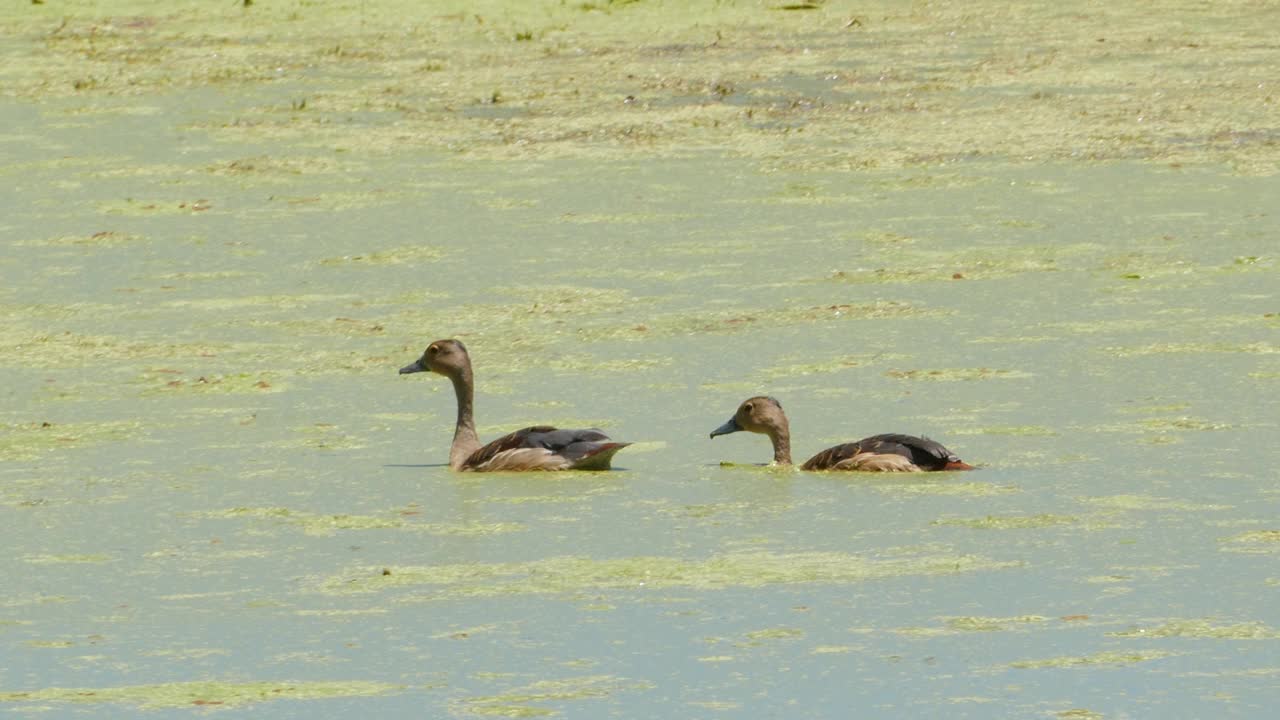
0,1 -> 1280,717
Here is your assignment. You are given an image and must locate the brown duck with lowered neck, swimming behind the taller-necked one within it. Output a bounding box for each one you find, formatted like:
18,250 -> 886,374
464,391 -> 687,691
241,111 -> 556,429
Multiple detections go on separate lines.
712,395 -> 974,473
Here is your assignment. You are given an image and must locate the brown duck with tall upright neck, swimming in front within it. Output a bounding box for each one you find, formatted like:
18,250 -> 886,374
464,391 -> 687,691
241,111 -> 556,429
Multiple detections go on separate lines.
401,340 -> 631,473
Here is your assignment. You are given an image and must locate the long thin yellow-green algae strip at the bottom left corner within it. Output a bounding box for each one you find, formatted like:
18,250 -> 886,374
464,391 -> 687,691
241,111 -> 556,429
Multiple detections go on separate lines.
0,680 -> 403,710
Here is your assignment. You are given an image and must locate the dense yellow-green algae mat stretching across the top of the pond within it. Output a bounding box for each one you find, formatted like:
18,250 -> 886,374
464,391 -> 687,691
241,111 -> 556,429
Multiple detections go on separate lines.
17,0 -> 1276,169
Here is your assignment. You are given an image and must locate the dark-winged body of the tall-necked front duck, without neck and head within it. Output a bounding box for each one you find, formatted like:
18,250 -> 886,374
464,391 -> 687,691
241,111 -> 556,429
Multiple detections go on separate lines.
460,425 -> 631,471
